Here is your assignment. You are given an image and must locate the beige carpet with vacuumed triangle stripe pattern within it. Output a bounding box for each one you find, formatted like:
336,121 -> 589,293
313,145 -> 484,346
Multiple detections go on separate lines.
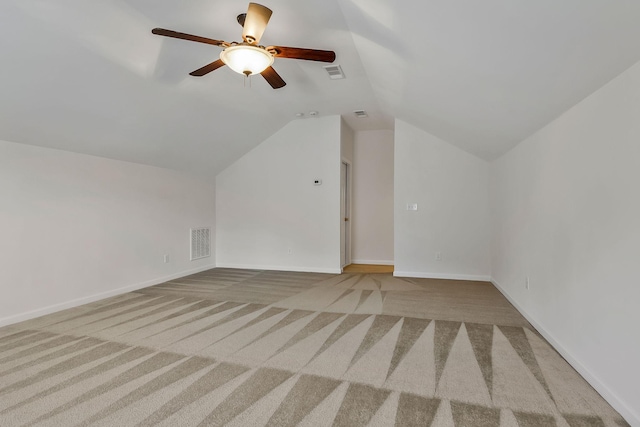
0,269 -> 627,427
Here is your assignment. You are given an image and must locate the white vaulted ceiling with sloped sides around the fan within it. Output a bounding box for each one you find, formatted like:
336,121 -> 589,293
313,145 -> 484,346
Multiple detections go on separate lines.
0,0 -> 640,175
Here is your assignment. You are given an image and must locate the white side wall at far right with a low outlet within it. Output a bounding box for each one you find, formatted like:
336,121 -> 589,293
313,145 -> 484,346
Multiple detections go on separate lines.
492,63 -> 640,426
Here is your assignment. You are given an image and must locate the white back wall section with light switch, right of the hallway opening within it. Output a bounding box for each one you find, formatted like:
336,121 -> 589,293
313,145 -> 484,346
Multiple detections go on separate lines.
394,120 -> 491,280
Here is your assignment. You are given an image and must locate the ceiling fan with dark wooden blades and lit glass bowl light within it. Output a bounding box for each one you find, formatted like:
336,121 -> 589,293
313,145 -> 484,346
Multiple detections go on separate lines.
151,3 -> 336,89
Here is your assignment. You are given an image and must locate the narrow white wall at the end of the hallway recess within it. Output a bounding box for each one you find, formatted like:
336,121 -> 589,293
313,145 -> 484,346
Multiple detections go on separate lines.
351,130 -> 393,264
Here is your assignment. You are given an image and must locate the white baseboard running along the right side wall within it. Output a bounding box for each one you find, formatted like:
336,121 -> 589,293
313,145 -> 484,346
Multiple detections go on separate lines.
491,278 -> 640,427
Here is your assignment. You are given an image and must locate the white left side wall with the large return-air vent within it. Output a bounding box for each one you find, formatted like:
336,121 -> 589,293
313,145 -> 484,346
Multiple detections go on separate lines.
0,141 -> 215,325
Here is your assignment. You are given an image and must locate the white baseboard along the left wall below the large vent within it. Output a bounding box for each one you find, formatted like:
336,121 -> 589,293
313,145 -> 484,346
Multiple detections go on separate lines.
0,265 -> 215,326
